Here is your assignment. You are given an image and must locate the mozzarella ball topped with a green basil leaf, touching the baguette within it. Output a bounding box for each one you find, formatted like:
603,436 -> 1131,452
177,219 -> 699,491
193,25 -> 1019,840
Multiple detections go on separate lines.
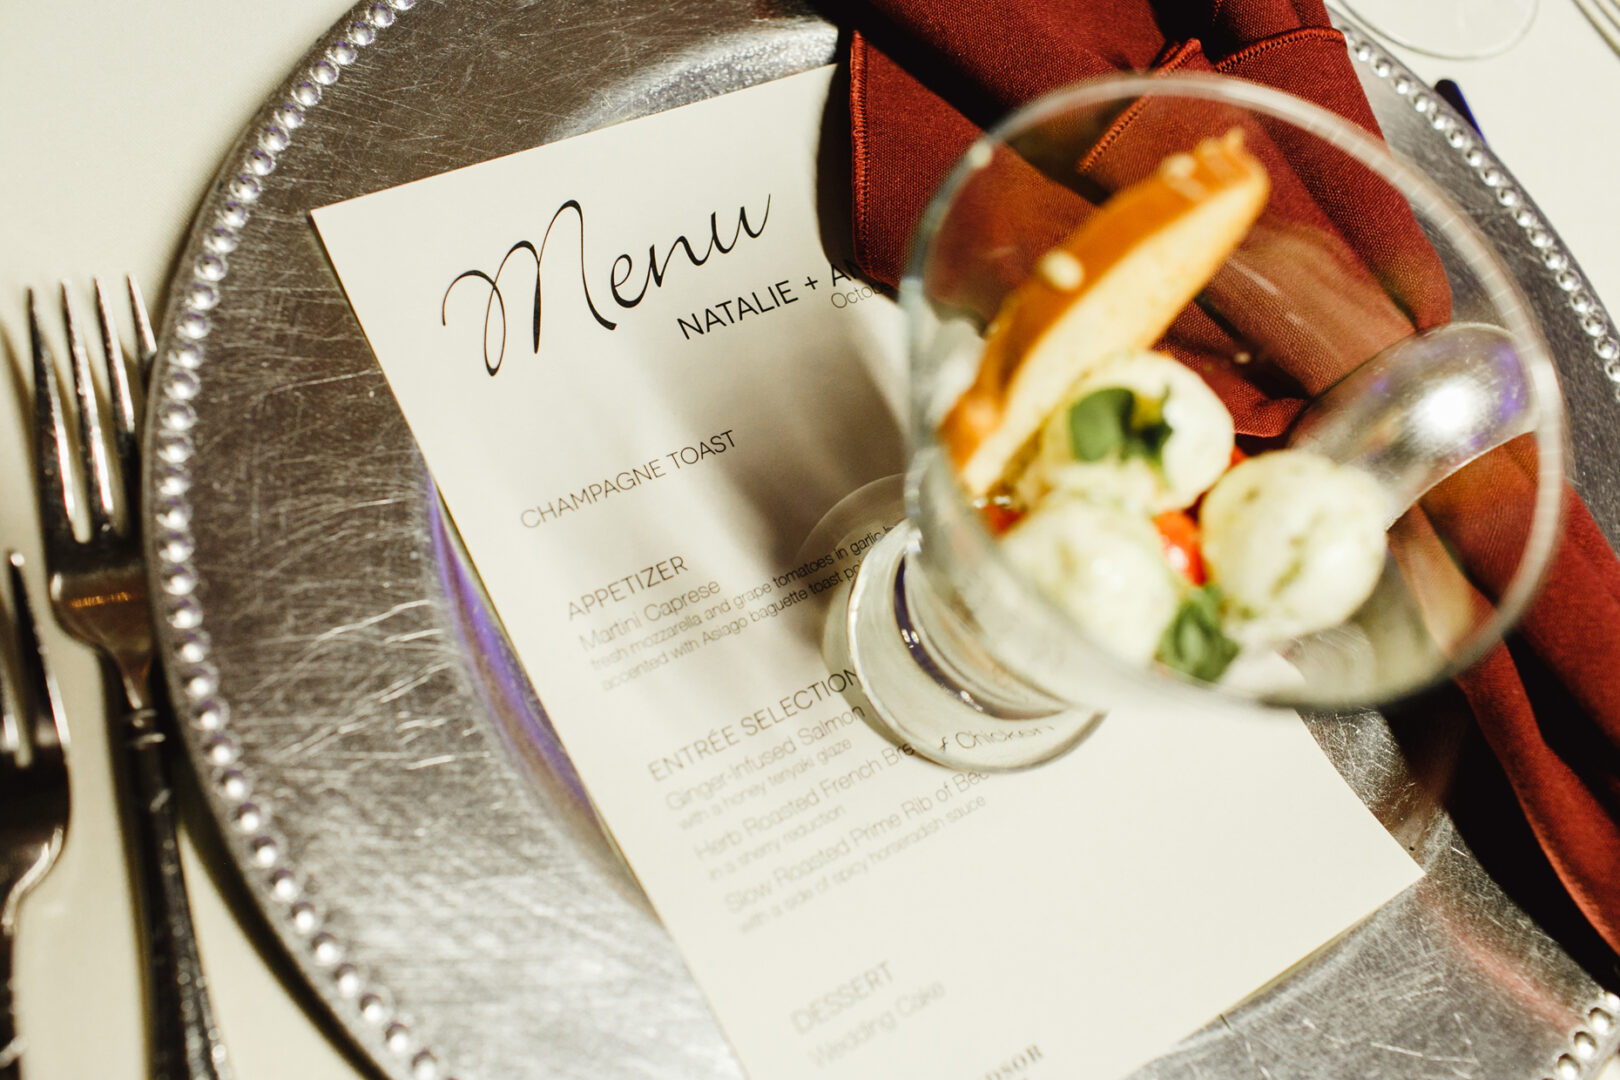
1019,353 -> 1233,515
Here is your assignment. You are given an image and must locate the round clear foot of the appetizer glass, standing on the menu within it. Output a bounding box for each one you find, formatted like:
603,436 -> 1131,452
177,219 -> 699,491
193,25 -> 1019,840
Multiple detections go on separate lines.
813,476 -> 1105,772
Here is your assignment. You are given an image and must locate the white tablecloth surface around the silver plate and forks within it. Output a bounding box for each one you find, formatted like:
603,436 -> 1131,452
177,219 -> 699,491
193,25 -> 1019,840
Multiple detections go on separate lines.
0,0 -> 1620,1080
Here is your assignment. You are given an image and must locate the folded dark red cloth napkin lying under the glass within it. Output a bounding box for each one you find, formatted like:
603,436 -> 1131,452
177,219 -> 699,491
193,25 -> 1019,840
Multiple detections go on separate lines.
842,0 -> 1620,952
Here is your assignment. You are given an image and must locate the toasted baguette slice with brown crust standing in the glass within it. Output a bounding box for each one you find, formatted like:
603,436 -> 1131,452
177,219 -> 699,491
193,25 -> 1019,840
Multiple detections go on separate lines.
940,128 -> 1270,495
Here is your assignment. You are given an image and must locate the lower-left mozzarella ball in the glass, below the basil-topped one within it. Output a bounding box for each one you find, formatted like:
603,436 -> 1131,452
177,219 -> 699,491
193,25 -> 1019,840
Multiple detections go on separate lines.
1003,495 -> 1184,667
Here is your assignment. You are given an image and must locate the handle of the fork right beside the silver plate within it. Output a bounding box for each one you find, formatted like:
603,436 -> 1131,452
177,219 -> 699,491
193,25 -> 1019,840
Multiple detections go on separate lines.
112,708 -> 230,1080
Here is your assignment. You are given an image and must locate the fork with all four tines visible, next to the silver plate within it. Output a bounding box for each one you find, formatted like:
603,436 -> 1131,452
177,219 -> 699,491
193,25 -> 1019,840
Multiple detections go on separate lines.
28,279 -> 230,1080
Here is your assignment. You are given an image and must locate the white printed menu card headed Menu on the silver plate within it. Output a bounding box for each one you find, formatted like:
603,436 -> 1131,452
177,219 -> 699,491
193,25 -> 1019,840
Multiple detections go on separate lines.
314,70 -> 1419,1080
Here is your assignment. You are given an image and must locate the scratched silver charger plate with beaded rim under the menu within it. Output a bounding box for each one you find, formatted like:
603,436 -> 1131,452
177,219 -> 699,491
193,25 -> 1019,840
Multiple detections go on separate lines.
147,0 -> 1620,1080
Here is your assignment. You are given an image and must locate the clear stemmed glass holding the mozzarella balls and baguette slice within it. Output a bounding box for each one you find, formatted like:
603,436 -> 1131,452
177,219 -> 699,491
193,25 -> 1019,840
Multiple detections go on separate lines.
816,76 -> 1563,771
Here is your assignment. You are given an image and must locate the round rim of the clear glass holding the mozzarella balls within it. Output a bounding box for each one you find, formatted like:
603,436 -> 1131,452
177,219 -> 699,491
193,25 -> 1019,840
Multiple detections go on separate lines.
899,73 -> 1567,709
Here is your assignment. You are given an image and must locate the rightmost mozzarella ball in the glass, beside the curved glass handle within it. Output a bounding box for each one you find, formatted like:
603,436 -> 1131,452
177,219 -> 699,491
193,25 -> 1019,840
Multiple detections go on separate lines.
1199,450 -> 1388,646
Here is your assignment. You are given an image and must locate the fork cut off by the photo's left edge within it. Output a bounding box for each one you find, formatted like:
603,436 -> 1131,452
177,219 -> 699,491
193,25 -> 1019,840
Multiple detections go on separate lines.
0,552 -> 68,1080
